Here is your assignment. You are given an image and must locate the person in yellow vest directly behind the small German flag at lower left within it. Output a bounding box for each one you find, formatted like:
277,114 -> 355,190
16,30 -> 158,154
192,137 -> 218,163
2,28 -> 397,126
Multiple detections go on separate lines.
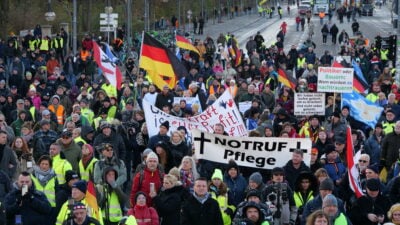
79,144 -> 98,181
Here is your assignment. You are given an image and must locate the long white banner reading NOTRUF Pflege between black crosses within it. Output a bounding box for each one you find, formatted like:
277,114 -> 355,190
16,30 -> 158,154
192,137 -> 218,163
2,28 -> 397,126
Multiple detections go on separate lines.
192,130 -> 312,169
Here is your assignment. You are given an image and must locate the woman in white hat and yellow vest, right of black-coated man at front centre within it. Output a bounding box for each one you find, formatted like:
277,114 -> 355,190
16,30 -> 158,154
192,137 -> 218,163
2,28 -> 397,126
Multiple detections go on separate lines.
208,169 -> 236,225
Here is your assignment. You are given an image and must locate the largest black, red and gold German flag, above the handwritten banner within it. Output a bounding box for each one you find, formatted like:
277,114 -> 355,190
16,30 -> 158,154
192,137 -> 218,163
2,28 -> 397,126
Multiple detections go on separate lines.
139,33 -> 188,89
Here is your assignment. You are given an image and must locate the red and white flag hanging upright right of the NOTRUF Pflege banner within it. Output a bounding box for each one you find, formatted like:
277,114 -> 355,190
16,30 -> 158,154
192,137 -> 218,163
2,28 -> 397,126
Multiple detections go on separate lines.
346,127 -> 363,198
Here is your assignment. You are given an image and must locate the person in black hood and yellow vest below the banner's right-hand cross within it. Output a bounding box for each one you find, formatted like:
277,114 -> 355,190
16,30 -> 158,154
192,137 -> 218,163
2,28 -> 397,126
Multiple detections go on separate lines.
293,171 -> 318,224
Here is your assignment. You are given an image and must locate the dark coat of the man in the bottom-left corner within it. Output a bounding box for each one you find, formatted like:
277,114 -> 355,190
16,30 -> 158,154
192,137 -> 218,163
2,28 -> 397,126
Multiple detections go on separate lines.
4,184 -> 51,225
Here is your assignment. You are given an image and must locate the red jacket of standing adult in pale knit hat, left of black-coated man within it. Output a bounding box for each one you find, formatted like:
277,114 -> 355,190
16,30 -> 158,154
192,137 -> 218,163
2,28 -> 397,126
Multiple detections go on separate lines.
130,167 -> 162,206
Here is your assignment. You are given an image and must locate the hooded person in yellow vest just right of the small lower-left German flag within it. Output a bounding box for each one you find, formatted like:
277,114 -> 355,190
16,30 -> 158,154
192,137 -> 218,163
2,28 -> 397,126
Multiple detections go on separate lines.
96,167 -> 128,225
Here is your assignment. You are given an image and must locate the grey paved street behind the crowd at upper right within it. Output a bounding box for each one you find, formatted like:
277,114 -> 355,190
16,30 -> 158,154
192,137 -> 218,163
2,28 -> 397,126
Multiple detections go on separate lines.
195,3 -> 393,56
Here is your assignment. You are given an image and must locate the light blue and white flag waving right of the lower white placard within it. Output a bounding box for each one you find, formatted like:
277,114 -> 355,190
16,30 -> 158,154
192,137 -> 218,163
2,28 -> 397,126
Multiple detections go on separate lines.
342,91 -> 383,128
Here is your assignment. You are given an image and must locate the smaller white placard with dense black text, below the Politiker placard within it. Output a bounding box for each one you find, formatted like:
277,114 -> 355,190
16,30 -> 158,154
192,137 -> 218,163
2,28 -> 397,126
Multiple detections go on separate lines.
294,92 -> 325,116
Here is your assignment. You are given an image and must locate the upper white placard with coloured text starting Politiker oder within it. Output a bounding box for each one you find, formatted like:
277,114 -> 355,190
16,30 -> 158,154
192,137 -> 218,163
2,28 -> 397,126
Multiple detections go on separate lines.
317,67 -> 354,93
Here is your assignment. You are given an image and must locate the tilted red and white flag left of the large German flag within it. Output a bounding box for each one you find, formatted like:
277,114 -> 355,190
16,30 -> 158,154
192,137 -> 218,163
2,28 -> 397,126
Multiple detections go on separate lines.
93,41 -> 122,90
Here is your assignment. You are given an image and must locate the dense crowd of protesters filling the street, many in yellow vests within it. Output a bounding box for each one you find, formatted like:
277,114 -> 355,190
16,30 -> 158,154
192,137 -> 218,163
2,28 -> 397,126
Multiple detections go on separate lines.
0,2 -> 400,225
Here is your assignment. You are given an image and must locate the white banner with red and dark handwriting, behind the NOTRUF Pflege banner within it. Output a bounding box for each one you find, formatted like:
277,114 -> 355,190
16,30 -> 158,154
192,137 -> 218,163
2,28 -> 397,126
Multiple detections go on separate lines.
143,91 -> 247,137
